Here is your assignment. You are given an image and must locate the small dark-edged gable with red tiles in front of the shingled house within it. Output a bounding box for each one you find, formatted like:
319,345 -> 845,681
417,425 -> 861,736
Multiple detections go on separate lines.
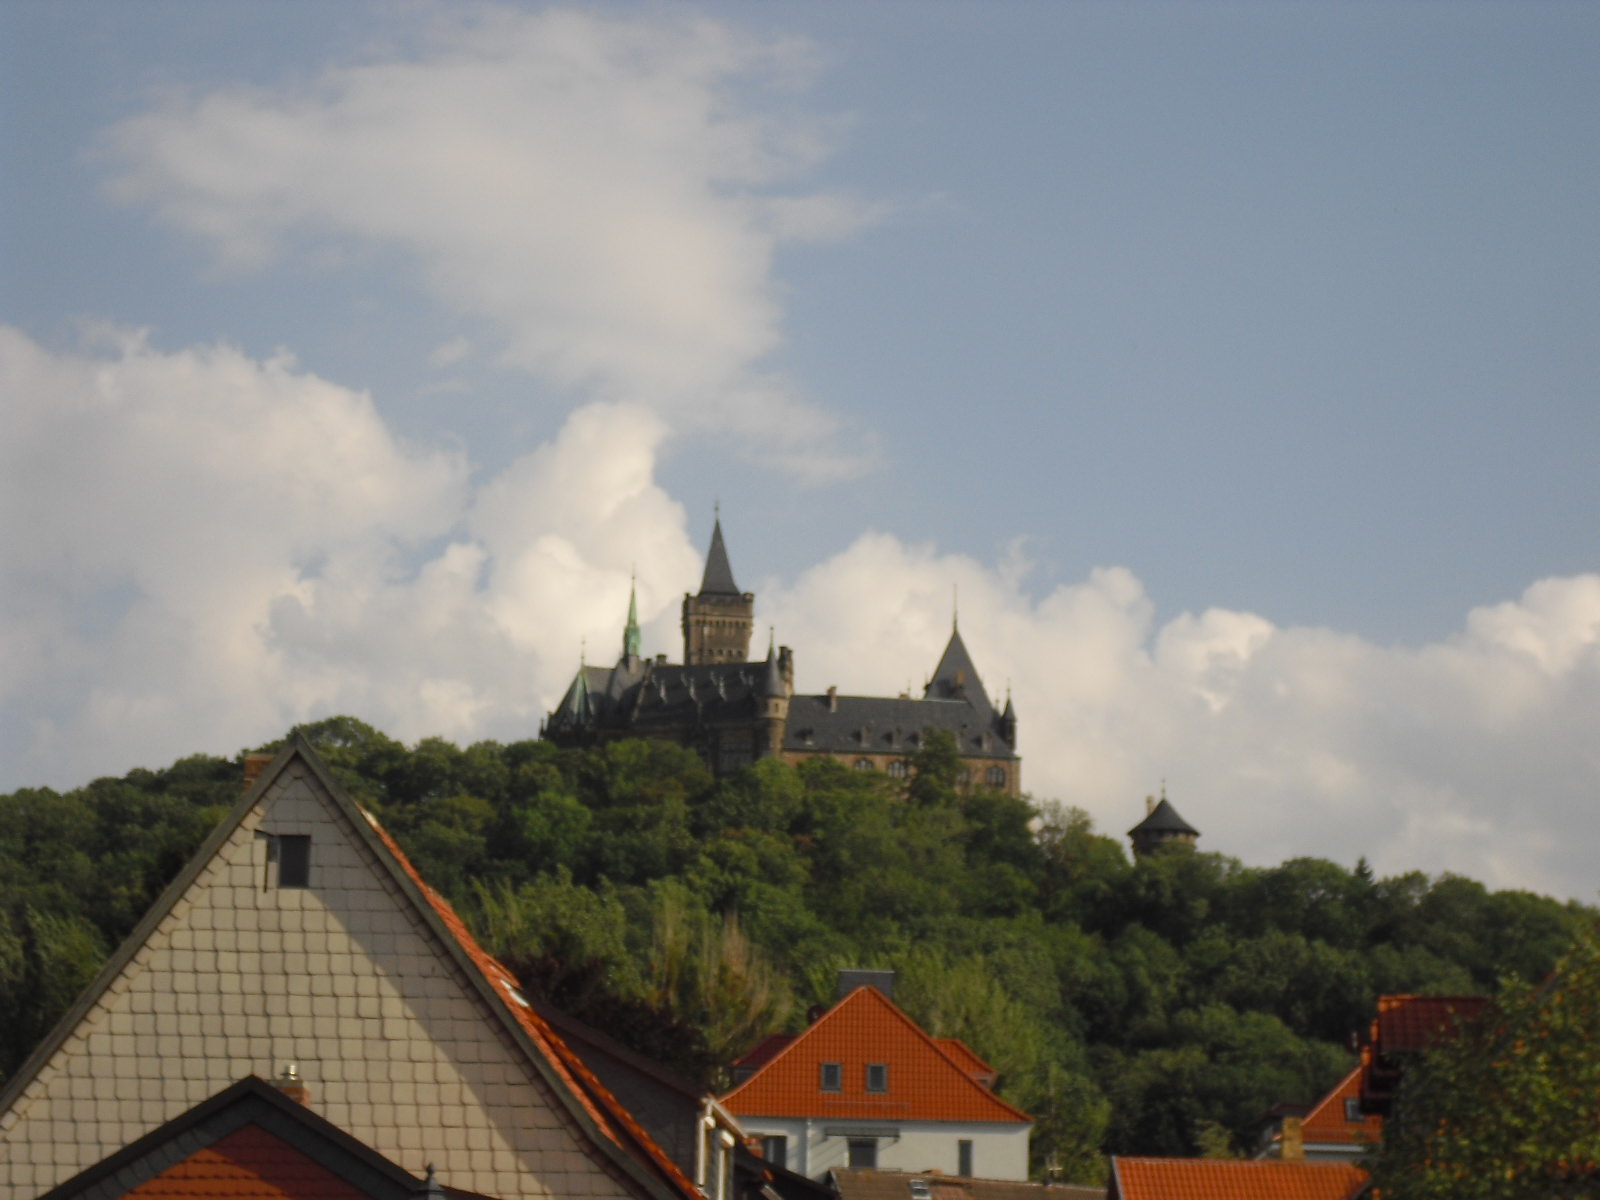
42,1075 -> 441,1200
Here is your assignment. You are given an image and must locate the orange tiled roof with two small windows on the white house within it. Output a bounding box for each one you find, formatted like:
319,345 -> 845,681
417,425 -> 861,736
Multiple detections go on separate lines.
722,987 -> 1032,1125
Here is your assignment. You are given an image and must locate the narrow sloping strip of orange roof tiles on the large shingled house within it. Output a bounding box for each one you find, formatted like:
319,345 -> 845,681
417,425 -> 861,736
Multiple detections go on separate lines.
363,810 -> 701,1200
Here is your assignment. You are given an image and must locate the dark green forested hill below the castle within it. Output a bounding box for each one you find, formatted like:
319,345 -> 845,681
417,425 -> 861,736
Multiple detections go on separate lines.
0,717 -> 1595,1182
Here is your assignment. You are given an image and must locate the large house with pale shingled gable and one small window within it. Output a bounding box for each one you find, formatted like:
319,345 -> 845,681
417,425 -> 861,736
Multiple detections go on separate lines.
0,736 -> 707,1200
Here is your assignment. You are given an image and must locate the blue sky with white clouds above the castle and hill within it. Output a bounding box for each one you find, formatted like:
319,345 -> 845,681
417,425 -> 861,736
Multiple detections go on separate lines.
0,0 -> 1600,902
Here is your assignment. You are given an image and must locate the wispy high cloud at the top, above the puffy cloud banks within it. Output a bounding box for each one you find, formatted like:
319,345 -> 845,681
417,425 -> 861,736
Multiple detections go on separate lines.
104,8 -> 877,475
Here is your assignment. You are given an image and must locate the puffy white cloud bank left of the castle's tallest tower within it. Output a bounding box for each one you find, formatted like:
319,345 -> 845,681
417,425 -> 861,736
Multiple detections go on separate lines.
0,328 -> 696,786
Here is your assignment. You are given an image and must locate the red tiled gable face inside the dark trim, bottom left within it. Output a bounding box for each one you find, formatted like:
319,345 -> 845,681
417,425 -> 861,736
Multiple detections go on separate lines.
123,1125 -> 366,1200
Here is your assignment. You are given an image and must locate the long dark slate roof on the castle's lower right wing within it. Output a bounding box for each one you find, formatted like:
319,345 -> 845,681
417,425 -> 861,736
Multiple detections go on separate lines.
784,694 -> 1016,758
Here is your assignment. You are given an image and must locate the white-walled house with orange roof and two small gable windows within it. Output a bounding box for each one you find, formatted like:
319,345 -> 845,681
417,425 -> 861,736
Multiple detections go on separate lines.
722,971 -> 1034,1181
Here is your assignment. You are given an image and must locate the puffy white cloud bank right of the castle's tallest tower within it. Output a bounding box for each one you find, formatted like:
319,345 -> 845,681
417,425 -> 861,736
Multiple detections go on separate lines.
766,533 -> 1600,901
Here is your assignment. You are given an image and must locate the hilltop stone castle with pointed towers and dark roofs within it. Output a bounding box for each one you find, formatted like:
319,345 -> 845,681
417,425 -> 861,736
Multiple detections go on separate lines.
539,518 -> 1022,795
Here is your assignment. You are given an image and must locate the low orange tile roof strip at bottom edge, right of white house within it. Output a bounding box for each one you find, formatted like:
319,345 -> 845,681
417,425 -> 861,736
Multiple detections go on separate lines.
1110,1158 -> 1366,1200
